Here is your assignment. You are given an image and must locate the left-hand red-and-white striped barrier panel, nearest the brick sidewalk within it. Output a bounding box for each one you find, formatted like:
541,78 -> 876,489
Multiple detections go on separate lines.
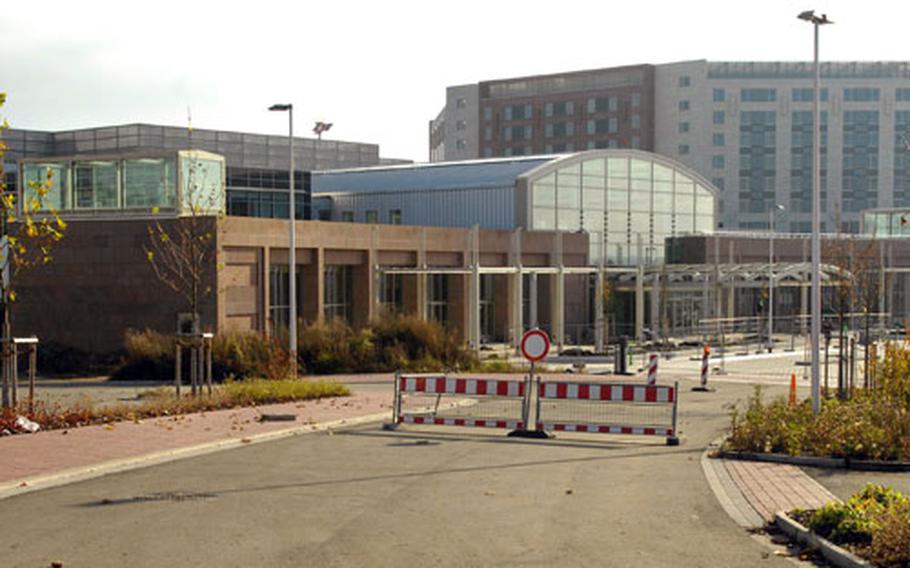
387,373 -> 528,430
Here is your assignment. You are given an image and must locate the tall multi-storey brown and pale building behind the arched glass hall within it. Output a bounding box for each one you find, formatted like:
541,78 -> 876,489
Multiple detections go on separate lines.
430,60 -> 910,233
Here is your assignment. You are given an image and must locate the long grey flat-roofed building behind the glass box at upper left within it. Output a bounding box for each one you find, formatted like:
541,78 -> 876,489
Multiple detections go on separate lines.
2,124 -> 406,219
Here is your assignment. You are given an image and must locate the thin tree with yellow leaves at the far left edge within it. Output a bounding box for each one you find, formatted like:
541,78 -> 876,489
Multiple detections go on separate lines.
0,93 -> 66,408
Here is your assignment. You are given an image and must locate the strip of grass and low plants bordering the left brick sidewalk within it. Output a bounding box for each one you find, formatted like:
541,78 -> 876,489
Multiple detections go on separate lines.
0,379 -> 350,433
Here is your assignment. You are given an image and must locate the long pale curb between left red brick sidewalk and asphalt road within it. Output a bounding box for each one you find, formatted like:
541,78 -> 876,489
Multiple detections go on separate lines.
0,412 -> 389,500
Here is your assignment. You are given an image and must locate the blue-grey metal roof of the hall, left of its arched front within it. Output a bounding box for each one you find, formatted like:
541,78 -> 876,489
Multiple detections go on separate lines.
313,156 -> 556,193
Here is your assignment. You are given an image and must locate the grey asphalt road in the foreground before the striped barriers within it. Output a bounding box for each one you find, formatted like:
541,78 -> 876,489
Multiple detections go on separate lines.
0,378 -> 792,567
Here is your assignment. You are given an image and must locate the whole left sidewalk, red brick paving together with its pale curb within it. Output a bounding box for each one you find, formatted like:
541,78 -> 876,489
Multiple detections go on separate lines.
0,387 -> 392,499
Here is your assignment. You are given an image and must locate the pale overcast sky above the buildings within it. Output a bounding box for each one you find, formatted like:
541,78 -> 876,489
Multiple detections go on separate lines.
0,0 -> 910,161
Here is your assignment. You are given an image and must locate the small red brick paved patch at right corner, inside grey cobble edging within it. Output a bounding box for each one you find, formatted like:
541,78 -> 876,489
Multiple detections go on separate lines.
724,460 -> 836,521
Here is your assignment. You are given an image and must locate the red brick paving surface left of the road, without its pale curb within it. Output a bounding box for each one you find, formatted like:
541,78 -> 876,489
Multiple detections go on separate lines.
0,389 -> 392,486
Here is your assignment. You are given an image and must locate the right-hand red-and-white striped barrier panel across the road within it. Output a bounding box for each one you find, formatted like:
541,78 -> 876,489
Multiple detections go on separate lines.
536,382 -> 679,445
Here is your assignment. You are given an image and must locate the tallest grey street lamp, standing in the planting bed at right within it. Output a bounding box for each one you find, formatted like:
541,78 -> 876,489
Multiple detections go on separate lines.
797,10 -> 834,414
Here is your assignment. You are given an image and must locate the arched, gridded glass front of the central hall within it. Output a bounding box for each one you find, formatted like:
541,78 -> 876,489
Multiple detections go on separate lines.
528,151 -> 717,265
